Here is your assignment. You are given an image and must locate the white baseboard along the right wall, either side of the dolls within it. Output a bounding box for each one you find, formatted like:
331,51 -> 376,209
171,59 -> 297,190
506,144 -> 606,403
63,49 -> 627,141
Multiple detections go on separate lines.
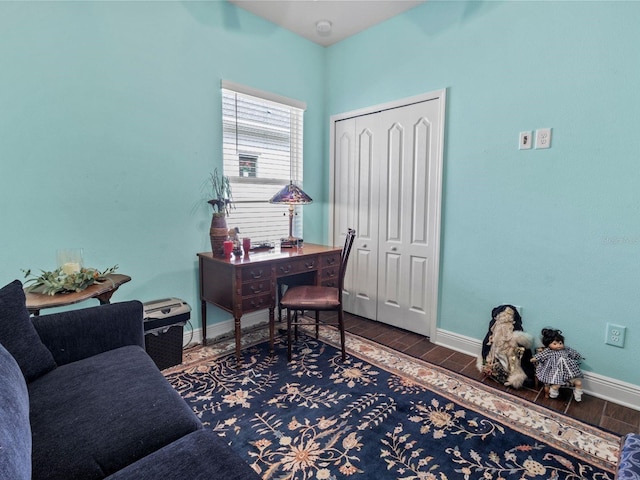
433,329 -> 640,410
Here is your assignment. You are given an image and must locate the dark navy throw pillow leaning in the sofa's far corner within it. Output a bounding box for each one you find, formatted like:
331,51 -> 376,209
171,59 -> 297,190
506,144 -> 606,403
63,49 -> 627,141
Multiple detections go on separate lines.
0,280 -> 56,382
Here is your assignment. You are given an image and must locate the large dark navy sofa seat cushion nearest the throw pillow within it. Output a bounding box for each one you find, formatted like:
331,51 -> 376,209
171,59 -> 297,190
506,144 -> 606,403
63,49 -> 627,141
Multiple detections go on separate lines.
28,346 -> 202,480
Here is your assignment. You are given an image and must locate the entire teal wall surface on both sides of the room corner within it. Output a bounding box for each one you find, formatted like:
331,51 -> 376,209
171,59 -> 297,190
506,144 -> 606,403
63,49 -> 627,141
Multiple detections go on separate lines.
0,0 -> 640,385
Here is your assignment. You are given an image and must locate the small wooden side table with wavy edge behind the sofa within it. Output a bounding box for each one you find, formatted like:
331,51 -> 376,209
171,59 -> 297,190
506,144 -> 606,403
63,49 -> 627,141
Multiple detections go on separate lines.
24,273 -> 131,315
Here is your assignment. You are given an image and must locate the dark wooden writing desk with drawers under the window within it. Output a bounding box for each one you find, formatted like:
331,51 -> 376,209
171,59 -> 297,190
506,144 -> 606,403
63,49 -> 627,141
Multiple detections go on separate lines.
198,243 -> 342,361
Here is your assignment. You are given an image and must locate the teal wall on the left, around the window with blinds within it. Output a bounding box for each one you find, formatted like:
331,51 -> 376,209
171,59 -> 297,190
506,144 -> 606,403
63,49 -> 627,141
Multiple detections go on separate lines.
0,2 -> 327,325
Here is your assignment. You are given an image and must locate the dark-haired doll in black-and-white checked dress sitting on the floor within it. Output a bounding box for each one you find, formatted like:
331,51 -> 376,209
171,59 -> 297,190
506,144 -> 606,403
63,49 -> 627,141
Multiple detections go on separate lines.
531,328 -> 583,402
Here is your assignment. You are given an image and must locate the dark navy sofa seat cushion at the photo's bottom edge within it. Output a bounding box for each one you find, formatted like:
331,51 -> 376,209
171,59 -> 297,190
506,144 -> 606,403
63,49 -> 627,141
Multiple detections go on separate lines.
107,430 -> 260,480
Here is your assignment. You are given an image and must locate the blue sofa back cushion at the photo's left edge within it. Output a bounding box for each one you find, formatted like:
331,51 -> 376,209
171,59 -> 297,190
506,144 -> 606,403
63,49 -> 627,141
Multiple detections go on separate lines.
0,345 -> 31,480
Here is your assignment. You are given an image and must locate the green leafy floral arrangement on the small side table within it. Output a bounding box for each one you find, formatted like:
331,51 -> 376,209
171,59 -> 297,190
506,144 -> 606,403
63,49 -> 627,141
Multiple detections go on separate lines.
22,265 -> 118,295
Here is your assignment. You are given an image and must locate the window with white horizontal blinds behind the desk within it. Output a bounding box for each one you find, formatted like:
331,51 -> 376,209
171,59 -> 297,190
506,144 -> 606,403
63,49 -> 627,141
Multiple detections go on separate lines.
222,82 -> 304,244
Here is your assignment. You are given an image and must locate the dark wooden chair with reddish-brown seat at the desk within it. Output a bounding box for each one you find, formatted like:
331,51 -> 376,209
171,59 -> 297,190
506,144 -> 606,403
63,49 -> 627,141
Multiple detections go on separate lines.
280,228 -> 356,361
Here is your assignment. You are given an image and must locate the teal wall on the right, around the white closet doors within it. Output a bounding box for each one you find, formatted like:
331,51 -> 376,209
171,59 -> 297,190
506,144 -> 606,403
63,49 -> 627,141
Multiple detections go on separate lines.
327,1 -> 640,385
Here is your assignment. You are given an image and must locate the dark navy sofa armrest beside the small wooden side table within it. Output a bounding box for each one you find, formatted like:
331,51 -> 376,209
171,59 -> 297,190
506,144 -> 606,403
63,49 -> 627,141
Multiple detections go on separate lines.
33,300 -> 144,365
